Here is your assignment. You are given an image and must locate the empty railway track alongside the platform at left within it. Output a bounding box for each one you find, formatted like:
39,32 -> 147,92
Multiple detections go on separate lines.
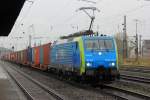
4,63 -> 66,100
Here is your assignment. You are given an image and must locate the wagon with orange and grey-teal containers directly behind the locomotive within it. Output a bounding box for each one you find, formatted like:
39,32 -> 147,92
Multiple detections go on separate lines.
27,43 -> 51,70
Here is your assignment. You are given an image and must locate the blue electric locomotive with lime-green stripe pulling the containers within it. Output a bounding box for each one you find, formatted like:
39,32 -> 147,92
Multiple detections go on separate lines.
49,32 -> 119,80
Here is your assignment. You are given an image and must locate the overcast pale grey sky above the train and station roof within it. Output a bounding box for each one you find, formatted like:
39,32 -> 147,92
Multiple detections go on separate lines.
1,0 -> 150,48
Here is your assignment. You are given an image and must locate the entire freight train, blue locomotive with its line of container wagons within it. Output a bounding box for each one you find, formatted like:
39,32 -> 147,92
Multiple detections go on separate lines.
3,31 -> 120,82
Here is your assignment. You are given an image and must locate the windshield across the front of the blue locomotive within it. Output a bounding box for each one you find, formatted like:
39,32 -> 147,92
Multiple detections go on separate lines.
85,39 -> 113,50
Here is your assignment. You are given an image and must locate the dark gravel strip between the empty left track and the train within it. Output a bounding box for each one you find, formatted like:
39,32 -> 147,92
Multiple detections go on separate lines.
2,61 -> 118,100
